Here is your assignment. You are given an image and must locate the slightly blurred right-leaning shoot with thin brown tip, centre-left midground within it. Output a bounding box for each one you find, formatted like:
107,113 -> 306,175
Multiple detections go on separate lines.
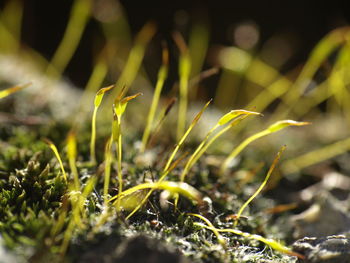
140,43 -> 169,152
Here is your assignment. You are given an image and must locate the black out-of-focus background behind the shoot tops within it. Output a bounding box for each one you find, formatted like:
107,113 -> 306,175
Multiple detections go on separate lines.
1,0 -> 350,86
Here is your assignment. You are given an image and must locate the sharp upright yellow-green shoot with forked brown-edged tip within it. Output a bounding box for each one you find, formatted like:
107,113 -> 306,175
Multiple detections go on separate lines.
112,87 -> 142,212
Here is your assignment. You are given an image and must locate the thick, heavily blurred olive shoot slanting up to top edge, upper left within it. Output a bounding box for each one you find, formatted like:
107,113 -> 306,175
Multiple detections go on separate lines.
46,0 -> 92,79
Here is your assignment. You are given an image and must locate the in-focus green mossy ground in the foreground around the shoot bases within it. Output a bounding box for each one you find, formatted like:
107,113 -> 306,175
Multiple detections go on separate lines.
0,110 -> 293,262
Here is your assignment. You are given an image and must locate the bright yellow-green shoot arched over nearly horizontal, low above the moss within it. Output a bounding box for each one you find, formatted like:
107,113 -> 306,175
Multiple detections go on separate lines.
109,181 -> 202,208
